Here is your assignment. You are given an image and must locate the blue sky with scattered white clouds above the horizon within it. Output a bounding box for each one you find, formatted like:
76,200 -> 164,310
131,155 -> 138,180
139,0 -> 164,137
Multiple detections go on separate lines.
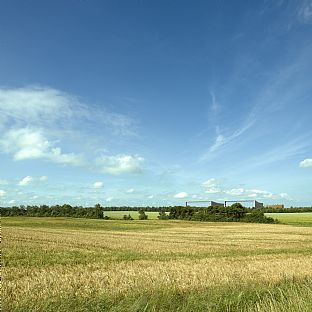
0,0 -> 312,206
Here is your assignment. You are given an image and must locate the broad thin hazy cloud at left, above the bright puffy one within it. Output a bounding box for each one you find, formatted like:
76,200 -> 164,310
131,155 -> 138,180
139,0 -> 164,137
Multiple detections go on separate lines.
0,86 -> 135,135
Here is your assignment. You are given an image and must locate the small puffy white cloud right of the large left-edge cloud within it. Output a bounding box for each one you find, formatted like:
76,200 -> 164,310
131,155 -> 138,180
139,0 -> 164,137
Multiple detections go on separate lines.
96,154 -> 144,175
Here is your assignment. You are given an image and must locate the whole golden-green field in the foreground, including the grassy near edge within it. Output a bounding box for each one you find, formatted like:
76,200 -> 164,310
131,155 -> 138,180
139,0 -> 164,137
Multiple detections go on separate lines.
2,217 -> 312,312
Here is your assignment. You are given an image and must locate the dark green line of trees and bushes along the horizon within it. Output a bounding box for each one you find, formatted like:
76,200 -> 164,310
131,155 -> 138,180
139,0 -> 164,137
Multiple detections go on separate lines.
1,203 -> 286,223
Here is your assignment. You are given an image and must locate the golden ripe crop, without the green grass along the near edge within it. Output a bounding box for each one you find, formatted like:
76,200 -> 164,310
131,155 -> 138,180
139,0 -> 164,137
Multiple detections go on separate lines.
3,219 -> 312,310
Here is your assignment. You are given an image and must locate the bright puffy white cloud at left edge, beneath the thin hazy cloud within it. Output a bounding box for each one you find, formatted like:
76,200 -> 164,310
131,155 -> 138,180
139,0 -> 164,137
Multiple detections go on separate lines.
0,128 -> 83,166
